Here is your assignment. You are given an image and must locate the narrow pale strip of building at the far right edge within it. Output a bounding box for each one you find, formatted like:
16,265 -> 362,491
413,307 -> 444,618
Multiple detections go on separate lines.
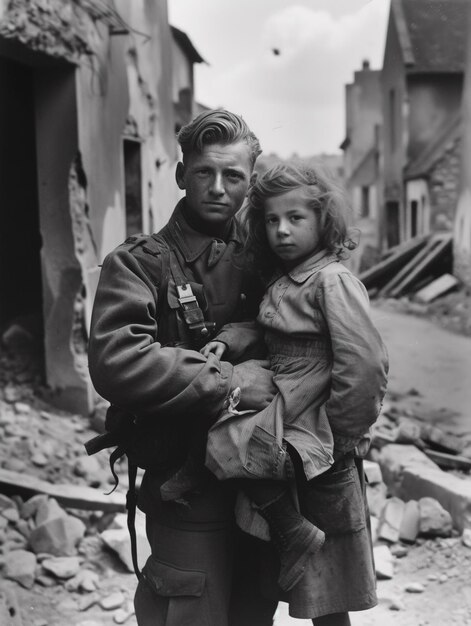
453,3 -> 471,288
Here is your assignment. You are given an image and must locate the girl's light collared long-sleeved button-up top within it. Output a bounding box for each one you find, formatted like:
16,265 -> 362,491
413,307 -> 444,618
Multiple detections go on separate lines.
217,251 -> 388,453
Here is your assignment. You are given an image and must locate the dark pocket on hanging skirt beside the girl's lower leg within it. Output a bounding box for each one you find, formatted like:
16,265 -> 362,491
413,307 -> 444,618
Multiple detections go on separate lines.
302,465 -> 366,535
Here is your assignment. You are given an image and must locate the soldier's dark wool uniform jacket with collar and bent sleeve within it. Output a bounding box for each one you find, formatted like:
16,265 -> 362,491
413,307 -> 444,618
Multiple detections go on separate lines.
89,200 -> 256,460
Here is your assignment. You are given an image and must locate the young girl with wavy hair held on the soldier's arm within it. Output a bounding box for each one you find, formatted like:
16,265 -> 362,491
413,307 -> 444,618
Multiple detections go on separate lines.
202,164 -> 387,625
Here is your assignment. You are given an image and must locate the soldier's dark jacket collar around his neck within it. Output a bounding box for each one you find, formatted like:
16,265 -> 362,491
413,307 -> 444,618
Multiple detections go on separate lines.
168,198 -> 242,263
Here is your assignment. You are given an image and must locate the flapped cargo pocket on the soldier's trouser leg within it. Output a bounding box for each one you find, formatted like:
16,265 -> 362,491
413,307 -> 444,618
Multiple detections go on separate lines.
142,556 -> 211,626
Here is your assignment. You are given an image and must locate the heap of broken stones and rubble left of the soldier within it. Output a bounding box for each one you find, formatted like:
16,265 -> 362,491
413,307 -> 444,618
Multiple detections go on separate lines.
0,394 -> 149,626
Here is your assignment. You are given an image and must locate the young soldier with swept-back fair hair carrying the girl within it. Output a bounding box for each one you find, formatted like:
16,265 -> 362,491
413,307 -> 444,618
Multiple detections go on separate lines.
89,110 -> 276,626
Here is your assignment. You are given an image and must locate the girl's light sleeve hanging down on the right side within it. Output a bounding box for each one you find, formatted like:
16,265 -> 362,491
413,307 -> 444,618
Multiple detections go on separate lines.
316,271 -> 388,452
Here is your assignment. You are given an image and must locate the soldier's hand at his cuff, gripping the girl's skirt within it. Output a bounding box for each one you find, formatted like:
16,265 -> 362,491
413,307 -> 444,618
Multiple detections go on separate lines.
232,359 -> 277,411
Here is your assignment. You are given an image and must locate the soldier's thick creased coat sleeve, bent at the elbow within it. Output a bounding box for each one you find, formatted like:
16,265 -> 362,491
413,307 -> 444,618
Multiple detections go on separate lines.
89,246 -> 232,418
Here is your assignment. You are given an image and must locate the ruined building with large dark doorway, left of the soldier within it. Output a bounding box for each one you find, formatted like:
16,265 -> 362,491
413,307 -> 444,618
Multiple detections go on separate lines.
0,0 -> 194,412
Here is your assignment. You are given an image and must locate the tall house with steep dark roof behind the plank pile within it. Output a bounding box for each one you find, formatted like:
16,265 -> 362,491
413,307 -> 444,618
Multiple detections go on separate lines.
381,0 -> 468,247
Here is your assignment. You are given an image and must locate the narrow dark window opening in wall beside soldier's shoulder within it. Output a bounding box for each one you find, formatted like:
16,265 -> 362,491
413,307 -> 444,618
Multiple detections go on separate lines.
123,139 -> 142,237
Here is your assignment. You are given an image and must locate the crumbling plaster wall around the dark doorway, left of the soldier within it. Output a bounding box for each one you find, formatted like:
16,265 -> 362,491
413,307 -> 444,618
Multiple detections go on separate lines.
0,0 -> 179,412
